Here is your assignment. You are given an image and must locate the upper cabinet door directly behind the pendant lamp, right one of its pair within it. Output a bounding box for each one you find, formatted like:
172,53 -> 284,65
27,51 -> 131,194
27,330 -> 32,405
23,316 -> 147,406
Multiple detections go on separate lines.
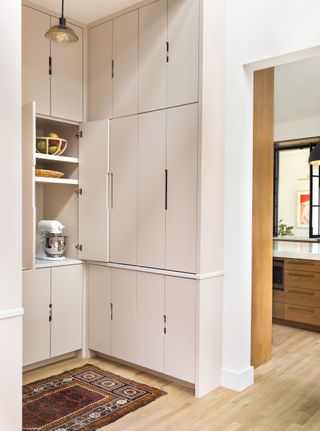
51,18 -> 83,121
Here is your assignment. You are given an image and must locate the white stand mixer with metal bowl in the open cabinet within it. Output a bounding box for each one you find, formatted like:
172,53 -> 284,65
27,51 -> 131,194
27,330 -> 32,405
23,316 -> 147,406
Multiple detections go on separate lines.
37,220 -> 67,260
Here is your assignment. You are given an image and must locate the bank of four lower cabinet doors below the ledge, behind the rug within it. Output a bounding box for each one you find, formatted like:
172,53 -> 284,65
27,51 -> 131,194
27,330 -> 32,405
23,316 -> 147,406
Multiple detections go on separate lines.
88,265 -> 196,383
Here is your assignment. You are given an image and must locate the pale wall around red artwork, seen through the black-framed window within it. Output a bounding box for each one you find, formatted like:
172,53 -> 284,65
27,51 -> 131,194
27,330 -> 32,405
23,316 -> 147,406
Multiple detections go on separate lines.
278,148 -> 310,237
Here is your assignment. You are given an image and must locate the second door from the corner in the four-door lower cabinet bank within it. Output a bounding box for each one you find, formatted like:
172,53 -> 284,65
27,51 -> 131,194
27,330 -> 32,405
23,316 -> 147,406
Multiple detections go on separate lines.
111,269 -> 137,362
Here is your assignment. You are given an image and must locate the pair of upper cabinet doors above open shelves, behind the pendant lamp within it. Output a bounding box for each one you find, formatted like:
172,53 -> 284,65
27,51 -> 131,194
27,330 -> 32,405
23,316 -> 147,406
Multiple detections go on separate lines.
22,5 -> 83,121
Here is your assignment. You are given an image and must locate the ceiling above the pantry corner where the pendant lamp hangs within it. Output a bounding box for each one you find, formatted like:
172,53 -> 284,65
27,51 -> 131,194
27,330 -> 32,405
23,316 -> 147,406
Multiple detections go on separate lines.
31,0 -> 138,24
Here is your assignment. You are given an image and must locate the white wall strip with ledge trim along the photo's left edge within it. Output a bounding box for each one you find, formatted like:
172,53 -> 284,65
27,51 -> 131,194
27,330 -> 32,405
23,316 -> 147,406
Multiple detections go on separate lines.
0,0 -> 22,431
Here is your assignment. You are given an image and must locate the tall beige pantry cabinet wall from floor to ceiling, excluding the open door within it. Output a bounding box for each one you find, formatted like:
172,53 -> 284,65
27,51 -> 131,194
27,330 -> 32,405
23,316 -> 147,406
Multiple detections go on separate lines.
86,0 -> 224,396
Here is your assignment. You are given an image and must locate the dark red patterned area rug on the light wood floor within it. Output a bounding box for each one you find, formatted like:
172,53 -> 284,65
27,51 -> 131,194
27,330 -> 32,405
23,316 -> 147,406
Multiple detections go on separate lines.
22,364 -> 166,431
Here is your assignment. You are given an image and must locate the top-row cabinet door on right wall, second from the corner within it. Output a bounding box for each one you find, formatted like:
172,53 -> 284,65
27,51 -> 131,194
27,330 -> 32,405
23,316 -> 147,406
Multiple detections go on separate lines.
113,10 -> 139,117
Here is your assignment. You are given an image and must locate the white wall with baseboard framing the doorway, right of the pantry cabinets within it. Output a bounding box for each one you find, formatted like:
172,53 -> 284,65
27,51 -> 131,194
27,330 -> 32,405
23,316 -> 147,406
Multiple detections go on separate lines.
222,0 -> 320,389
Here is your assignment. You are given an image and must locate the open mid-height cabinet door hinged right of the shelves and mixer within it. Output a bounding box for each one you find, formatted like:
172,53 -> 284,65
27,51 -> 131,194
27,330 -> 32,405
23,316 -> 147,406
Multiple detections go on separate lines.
79,120 -> 109,262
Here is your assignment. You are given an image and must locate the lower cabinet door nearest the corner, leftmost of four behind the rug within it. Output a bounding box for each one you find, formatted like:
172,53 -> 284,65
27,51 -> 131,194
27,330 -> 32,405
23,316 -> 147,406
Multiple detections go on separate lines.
88,265 -> 112,355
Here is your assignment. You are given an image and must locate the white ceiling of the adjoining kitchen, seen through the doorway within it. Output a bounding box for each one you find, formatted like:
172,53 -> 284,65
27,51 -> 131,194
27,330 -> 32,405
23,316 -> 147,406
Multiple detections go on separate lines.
275,56 -> 320,123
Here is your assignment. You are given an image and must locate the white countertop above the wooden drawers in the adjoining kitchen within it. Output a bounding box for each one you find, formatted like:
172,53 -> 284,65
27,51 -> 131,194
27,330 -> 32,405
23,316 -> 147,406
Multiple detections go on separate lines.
273,241 -> 320,260
